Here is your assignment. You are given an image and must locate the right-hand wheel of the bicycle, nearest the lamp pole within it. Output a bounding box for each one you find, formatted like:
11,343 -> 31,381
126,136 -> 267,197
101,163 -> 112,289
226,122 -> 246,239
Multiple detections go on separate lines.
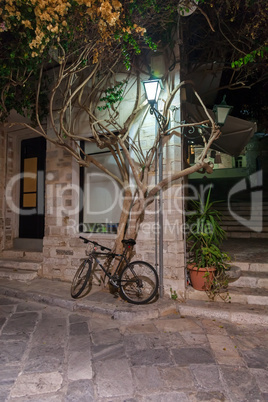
119,261 -> 158,304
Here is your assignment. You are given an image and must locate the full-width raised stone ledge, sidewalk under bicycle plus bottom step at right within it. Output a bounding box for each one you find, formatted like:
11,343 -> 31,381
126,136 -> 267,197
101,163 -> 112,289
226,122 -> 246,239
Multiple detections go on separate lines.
0,278 -> 268,326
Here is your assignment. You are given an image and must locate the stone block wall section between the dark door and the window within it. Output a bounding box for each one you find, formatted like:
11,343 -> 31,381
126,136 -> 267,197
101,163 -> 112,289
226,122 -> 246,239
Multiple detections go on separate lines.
43,142 -> 79,280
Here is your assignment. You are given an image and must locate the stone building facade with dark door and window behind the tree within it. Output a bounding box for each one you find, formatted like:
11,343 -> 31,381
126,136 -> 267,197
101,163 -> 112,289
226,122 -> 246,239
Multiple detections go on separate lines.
0,52 -> 188,297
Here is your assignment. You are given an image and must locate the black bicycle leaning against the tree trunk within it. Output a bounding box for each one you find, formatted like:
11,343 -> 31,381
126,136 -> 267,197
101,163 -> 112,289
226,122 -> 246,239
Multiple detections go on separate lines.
71,236 -> 159,304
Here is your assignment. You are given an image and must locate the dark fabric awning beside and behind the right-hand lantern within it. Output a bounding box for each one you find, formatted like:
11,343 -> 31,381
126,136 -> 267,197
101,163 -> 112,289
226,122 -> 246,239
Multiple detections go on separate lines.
185,103 -> 257,156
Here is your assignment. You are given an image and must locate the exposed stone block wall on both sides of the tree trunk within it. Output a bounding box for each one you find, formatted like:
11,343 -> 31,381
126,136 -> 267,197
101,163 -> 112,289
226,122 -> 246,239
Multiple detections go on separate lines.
42,125 -> 185,295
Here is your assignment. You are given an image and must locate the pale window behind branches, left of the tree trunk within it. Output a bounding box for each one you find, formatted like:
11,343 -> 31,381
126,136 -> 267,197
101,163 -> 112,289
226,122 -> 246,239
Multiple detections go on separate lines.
80,143 -> 121,233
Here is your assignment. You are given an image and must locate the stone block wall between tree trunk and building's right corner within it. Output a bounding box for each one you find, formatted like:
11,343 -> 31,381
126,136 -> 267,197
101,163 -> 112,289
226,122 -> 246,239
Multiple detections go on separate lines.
135,146 -> 185,297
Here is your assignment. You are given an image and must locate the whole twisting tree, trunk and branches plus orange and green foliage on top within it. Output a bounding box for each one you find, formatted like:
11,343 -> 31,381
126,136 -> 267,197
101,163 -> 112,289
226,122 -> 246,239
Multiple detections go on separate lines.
4,0 -> 262,270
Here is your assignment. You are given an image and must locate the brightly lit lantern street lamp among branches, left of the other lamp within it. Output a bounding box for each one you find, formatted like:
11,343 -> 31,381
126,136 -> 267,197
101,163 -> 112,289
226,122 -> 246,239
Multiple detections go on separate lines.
142,78 -> 167,132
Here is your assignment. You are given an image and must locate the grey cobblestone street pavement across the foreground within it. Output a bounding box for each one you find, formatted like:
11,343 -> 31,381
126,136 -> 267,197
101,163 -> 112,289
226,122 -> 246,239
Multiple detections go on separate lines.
0,296 -> 268,402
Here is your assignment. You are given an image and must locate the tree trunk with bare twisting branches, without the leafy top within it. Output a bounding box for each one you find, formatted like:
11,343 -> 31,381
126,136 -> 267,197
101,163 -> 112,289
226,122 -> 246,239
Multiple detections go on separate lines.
10,50 -> 220,270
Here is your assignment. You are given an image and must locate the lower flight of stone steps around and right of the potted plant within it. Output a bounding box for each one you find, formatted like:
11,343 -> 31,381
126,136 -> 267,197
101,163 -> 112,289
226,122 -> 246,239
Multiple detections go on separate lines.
187,238 -> 268,306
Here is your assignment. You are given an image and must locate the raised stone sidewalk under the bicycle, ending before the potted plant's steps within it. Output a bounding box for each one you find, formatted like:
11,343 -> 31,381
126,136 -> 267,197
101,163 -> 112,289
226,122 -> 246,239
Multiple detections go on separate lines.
0,278 -> 178,321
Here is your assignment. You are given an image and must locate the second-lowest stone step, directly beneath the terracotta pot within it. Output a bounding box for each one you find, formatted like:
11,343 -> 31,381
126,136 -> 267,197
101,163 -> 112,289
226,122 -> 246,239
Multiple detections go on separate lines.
186,286 -> 268,306
